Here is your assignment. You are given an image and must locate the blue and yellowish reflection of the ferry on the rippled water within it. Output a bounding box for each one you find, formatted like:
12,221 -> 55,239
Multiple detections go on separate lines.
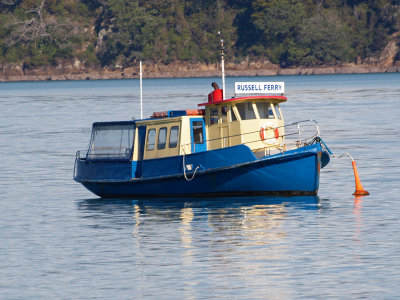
77,196 -> 322,257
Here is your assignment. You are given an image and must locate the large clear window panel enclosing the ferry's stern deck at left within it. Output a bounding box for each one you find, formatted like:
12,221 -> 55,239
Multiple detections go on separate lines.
88,124 -> 135,159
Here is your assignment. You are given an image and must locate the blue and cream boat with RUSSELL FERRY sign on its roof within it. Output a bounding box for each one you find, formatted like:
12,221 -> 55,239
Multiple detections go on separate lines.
74,82 -> 332,198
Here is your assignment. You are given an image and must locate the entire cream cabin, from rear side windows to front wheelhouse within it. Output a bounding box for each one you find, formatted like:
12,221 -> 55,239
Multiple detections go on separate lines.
133,96 -> 286,161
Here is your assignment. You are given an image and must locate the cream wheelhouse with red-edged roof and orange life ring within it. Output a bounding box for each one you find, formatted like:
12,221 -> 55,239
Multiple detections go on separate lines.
206,96 -> 286,156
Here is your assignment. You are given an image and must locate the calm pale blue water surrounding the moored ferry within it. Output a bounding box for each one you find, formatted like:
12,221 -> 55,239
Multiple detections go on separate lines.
0,74 -> 400,299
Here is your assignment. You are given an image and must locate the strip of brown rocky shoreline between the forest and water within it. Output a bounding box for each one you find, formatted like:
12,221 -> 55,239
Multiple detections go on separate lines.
0,62 -> 400,82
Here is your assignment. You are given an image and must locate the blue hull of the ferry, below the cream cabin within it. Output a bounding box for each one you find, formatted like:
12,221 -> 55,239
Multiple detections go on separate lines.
75,143 -> 322,198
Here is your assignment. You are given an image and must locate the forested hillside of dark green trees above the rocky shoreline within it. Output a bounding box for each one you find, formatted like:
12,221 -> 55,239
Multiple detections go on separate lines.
0,0 -> 400,69
